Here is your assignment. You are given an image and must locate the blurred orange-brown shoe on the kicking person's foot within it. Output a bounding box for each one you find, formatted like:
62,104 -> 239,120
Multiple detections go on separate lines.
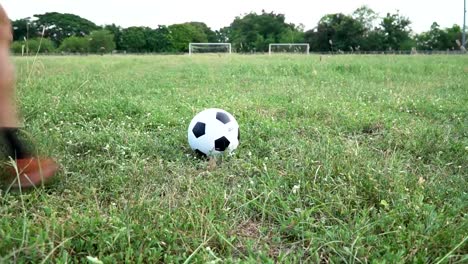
7,158 -> 59,188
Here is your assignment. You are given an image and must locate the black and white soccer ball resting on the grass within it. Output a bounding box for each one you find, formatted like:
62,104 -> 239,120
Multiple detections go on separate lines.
188,108 -> 240,156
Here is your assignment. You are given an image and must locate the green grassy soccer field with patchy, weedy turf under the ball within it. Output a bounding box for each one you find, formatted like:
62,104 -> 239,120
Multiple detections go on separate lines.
0,56 -> 468,263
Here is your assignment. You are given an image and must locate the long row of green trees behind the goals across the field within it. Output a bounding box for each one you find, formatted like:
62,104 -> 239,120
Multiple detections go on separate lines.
12,6 -> 464,53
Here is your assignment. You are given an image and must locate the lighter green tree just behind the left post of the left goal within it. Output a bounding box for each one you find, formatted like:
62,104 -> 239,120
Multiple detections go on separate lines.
169,23 -> 208,52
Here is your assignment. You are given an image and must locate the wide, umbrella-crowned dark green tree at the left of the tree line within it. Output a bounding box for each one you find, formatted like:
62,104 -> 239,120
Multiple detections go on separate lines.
34,12 -> 99,45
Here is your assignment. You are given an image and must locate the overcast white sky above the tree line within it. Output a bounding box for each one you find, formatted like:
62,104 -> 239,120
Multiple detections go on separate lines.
0,0 -> 464,32
